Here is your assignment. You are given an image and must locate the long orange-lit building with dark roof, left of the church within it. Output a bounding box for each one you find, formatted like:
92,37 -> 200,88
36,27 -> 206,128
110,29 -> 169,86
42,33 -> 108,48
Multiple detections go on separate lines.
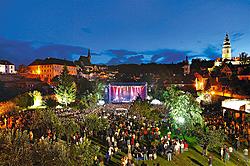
28,58 -> 77,83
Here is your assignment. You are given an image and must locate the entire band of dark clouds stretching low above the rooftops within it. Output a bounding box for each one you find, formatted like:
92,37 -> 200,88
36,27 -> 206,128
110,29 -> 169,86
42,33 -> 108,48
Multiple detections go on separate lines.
0,34 -> 230,65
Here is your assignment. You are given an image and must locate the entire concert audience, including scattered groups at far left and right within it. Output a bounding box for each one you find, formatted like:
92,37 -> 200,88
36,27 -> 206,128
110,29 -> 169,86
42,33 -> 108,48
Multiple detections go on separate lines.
0,102 -> 250,166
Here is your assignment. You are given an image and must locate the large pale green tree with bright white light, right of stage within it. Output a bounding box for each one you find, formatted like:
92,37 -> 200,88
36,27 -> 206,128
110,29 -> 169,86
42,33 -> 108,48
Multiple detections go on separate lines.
163,86 -> 203,129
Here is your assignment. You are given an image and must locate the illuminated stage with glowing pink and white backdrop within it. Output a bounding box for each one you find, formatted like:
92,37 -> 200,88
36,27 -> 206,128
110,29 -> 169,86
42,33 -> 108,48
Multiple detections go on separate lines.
107,83 -> 147,103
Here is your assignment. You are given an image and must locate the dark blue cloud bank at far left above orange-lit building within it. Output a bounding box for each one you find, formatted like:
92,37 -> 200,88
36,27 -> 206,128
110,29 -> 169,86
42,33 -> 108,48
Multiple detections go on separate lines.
0,38 -> 89,64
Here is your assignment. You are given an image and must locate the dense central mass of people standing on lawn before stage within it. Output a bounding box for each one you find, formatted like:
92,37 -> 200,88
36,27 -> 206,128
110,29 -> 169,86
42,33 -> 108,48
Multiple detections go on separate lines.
94,110 -> 188,165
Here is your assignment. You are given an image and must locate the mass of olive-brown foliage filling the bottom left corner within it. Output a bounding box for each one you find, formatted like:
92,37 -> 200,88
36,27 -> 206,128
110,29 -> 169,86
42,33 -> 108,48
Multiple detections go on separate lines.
0,130 -> 100,166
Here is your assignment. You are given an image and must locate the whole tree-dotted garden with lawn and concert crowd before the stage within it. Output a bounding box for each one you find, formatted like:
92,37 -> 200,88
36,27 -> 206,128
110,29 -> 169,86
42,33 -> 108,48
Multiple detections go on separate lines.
0,68 -> 249,166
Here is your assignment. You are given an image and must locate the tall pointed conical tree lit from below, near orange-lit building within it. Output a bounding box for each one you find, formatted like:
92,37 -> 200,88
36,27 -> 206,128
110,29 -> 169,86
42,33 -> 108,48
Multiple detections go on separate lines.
55,66 -> 76,107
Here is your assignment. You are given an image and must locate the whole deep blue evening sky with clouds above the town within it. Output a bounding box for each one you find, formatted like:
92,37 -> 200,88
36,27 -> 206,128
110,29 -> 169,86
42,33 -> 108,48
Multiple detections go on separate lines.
0,0 -> 250,64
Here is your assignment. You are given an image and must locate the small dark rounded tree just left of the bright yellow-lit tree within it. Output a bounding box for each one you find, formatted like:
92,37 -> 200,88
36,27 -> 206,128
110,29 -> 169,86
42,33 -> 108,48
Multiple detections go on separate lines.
15,92 -> 34,108
